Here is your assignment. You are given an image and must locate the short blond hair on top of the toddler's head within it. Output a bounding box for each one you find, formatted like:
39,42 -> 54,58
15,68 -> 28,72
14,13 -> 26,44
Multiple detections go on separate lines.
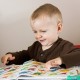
31,4 -> 63,23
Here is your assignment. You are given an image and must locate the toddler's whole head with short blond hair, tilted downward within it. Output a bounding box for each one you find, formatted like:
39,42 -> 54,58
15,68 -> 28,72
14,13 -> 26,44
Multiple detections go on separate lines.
31,4 -> 62,46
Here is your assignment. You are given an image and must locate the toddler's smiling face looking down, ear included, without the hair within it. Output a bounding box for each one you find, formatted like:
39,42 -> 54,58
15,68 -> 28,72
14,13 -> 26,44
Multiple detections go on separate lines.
31,16 -> 61,46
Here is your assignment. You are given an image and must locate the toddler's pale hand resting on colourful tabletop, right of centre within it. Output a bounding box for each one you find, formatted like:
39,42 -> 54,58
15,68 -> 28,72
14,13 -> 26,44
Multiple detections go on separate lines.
45,57 -> 62,70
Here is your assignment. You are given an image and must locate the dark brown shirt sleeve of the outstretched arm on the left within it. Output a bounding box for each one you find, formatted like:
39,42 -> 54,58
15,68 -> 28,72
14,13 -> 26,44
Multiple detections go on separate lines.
7,41 -> 39,65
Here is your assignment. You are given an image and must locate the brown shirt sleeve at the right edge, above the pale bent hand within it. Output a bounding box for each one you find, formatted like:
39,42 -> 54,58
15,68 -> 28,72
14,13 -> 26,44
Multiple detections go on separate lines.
60,43 -> 80,68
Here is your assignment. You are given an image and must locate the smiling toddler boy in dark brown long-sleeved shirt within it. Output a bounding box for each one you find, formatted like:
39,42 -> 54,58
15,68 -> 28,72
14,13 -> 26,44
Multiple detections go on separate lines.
1,4 -> 80,70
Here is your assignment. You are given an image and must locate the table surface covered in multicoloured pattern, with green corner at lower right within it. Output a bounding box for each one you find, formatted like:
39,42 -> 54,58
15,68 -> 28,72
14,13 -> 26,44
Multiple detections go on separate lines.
0,60 -> 80,80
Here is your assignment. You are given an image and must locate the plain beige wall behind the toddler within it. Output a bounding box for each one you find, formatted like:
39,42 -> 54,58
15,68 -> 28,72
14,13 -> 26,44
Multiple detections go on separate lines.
0,0 -> 80,66
